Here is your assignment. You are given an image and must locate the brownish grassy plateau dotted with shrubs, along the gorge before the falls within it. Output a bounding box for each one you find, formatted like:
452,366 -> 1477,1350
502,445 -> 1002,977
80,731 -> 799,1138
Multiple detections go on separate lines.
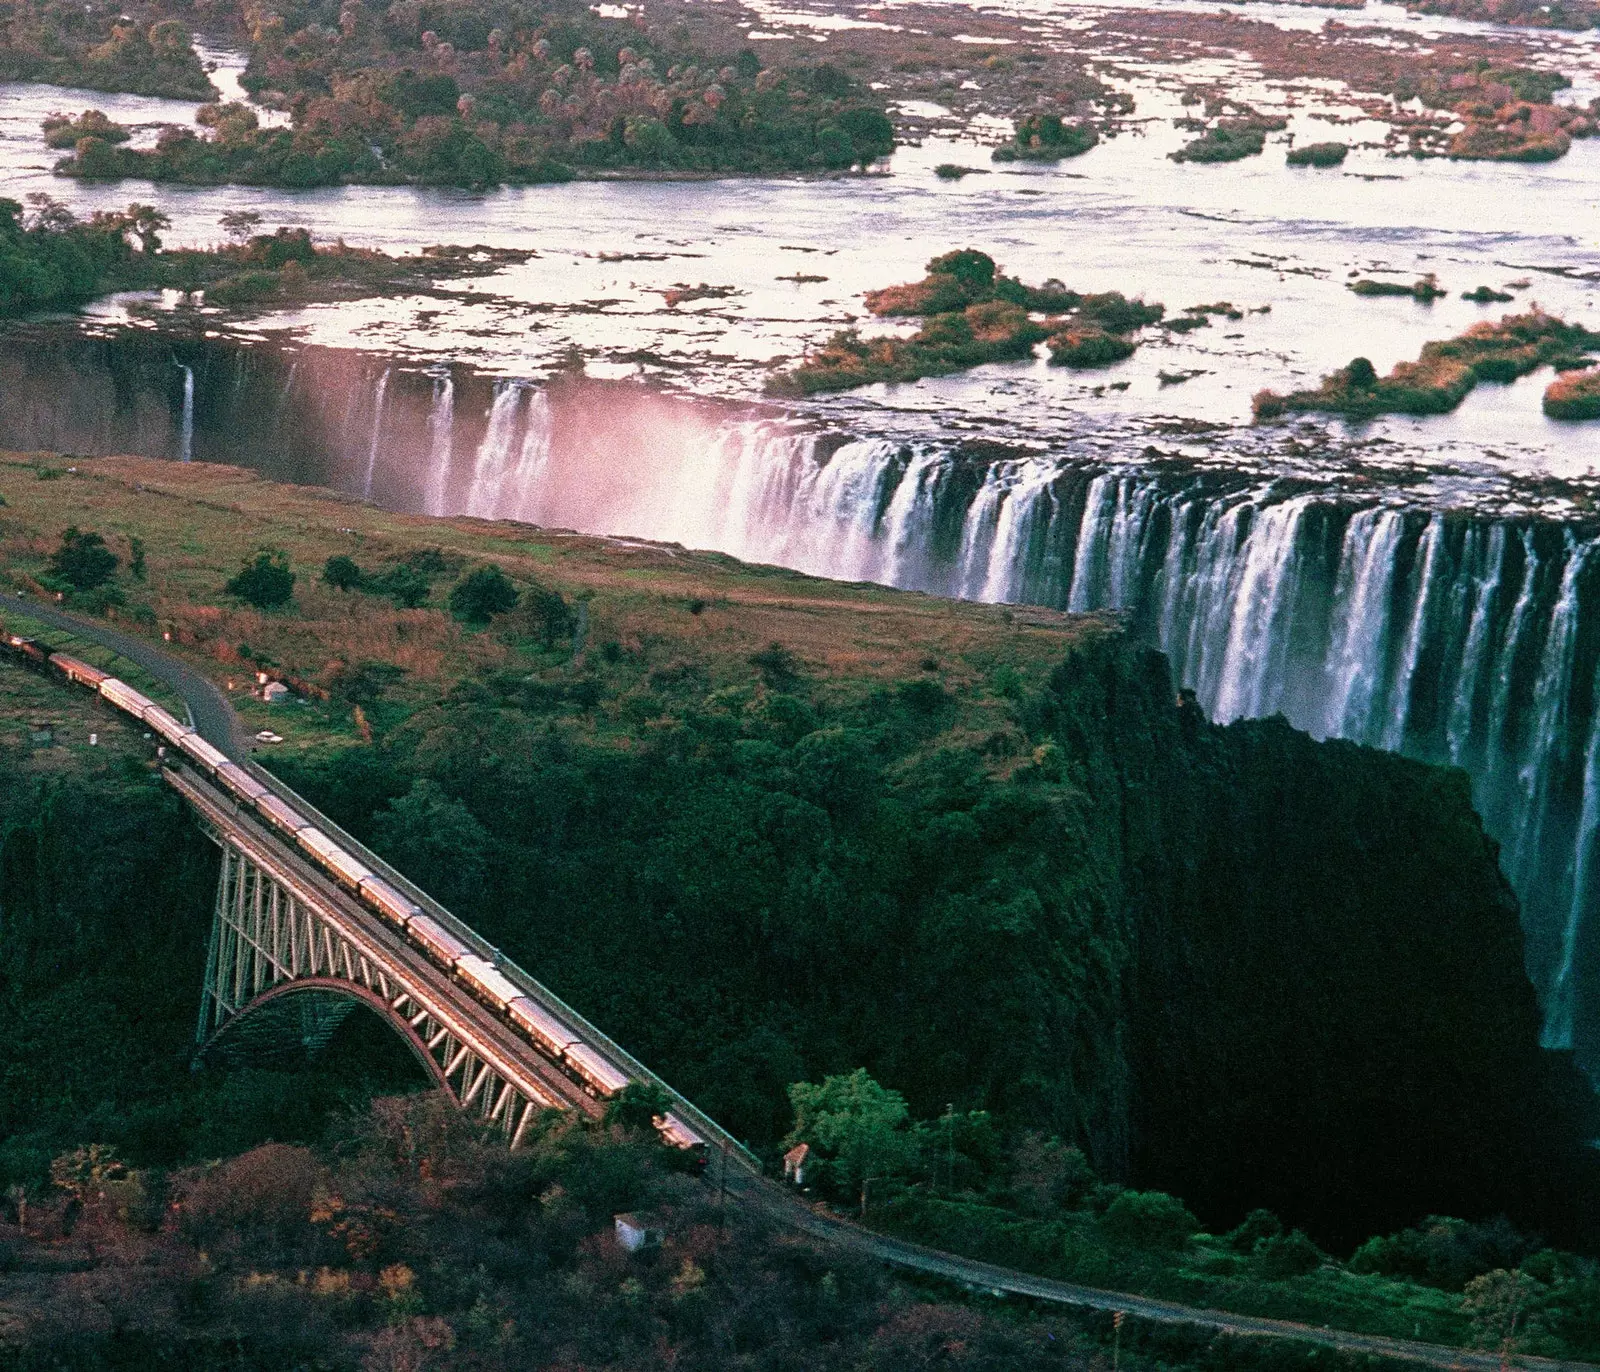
0,453 -> 1093,750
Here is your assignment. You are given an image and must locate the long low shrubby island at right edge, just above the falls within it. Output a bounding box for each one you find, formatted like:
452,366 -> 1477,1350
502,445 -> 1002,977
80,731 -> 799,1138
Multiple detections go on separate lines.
1254,305 -> 1600,419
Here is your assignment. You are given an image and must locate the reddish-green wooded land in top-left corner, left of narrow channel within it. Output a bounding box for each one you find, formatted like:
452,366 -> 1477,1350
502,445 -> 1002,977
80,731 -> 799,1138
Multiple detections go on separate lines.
0,0 -> 216,101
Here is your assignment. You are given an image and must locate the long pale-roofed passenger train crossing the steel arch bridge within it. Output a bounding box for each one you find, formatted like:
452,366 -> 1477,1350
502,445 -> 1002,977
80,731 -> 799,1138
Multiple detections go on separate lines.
0,632 -> 706,1161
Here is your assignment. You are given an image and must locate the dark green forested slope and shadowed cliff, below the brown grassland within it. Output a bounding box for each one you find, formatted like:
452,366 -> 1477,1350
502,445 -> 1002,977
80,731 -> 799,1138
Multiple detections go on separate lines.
262,636 -> 1576,1244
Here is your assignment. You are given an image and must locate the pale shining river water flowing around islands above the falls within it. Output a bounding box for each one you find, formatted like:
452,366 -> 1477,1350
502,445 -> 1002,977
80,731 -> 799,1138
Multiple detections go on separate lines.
0,3 -> 1600,495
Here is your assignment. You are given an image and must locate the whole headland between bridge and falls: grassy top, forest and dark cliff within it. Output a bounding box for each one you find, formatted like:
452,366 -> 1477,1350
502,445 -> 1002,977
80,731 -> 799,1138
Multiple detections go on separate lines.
0,457 -> 1581,1244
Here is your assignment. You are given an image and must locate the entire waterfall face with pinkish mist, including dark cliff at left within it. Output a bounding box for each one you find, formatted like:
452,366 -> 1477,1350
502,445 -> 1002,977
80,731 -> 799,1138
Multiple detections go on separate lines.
0,334 -> 1600,1073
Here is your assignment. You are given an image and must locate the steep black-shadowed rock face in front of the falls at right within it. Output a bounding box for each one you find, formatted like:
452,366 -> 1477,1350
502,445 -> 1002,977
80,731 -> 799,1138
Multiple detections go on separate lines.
1038,644 -> 1589,1244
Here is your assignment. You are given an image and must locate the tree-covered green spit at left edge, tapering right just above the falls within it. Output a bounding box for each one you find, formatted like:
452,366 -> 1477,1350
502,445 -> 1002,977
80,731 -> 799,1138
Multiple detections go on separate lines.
0,193 -> 540,318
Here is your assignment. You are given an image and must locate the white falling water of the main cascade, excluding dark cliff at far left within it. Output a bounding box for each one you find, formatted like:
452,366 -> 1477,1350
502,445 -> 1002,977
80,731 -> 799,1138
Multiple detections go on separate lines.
427,402 -> 1600,1048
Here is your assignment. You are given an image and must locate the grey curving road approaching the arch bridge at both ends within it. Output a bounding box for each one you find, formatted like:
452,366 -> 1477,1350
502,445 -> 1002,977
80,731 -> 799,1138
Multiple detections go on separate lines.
9,596 -> 1595,1372
